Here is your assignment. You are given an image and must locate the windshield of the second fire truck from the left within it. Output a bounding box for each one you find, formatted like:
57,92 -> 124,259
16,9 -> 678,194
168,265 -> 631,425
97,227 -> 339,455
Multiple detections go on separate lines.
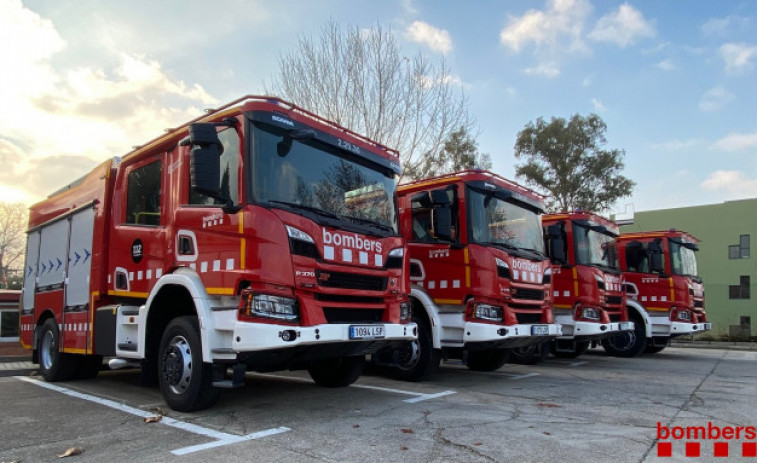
468,188 -> 544,254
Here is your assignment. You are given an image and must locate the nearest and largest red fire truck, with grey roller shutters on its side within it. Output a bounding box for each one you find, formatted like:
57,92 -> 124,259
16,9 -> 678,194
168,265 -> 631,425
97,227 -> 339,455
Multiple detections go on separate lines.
20,96 -> 416,411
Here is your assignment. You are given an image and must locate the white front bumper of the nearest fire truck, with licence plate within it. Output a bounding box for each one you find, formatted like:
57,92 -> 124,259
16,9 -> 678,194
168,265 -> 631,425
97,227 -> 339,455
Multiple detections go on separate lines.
231,322 -> 418,355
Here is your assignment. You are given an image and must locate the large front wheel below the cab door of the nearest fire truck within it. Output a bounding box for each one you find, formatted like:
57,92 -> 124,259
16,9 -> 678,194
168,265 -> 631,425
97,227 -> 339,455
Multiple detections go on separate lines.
158,316 -> 220,412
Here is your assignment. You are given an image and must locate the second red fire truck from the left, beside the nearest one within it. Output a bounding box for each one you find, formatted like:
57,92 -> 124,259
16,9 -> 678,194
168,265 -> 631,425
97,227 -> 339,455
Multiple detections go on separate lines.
378,170 -> 559,381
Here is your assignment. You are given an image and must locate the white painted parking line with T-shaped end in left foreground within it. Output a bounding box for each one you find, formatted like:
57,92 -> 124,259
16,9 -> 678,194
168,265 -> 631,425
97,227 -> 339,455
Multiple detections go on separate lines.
14,376 -> 291,455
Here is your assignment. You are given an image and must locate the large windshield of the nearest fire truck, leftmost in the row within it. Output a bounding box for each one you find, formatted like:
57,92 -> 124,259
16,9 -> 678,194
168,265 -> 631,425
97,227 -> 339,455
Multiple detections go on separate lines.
252,122 -> 397,234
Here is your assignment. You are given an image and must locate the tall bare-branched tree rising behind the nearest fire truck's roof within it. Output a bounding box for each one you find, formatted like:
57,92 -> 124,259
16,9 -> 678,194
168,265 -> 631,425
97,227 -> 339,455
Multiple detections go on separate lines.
266,21 -> 474,179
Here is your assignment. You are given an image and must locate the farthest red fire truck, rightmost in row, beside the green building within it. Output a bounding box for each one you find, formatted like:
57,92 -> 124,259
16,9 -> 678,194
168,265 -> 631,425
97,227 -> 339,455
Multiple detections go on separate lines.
603,230 -> 712,357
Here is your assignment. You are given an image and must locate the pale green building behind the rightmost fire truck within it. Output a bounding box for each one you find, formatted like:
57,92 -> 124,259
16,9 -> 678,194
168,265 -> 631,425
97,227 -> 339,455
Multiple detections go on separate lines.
618,198 -> 757,339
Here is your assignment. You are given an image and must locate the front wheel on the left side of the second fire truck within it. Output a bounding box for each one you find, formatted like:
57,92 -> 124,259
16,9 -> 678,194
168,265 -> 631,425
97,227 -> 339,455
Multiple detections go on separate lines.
392,317 -> 441,382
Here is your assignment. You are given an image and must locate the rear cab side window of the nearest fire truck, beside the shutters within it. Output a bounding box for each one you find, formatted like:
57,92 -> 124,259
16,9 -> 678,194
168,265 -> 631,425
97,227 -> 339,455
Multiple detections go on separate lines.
126,161 -> 160,225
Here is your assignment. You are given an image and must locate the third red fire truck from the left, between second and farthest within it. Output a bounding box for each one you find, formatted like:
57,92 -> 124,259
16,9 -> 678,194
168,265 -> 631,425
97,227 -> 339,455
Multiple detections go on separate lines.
542,211 -> 634,358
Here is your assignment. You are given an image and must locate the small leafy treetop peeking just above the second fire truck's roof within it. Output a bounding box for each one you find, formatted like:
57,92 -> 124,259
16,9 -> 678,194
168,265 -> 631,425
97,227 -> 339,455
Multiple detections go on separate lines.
417,126 -> 492,178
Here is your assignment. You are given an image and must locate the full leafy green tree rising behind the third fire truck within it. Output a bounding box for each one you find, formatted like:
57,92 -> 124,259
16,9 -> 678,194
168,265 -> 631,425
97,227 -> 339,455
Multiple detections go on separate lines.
515,114 -> 636,212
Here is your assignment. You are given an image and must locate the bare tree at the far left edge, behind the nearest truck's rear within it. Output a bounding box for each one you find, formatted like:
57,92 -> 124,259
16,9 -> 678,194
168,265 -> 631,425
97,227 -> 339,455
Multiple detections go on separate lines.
0,202 -> 28,288
